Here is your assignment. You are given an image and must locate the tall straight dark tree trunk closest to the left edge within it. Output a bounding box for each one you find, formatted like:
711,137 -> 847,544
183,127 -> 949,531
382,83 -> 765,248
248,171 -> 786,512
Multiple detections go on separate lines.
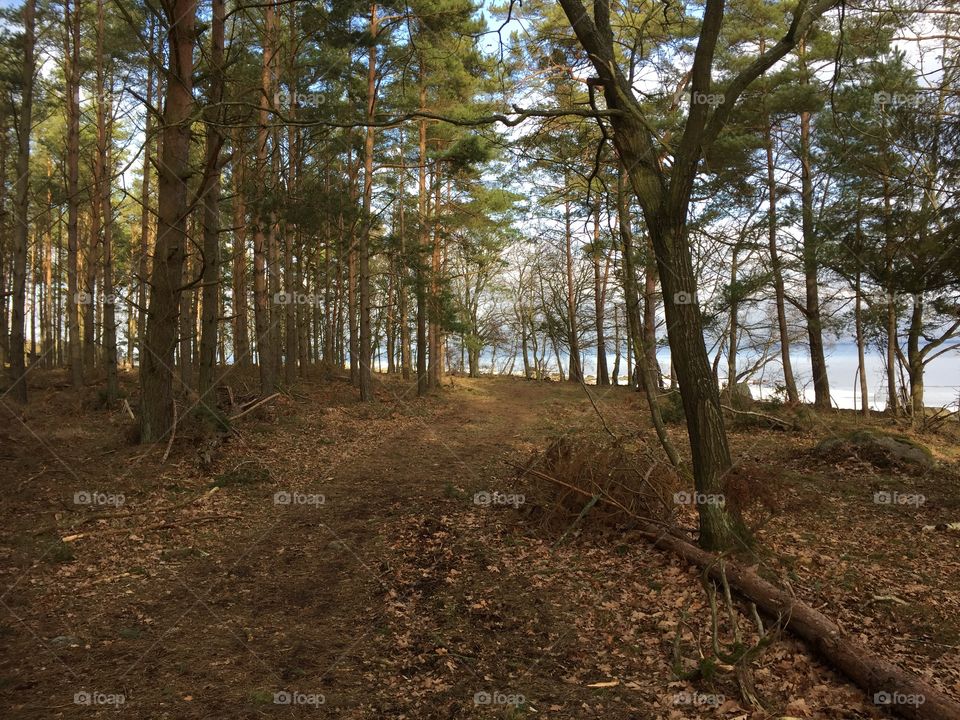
10,0 -> 36,403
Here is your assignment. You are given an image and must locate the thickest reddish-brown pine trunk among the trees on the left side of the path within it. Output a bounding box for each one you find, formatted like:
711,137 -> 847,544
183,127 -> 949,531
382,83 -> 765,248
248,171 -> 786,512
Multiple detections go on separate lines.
140,0 -> 197,442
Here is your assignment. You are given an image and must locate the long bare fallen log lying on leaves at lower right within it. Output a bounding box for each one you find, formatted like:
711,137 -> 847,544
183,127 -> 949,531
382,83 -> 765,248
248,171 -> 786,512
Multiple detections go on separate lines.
638,521 -> 960,720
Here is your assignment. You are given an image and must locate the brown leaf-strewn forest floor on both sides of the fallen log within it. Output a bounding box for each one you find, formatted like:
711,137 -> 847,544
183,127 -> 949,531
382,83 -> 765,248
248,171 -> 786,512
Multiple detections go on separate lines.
0,371 -> 960,720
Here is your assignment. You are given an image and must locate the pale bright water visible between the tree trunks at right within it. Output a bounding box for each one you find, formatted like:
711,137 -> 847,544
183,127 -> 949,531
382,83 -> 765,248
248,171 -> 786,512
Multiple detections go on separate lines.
462,342 -> 960,410
